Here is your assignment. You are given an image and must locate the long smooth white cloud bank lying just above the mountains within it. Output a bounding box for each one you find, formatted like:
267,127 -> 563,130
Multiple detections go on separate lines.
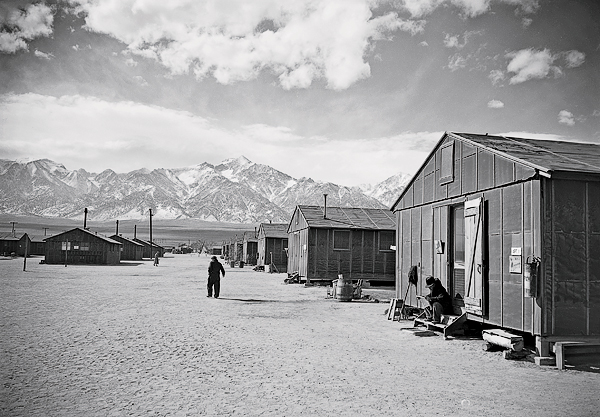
0,94 -> 443,185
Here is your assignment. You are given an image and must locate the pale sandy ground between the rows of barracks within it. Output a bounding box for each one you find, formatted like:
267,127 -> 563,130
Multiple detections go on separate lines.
0,255 -> 600,416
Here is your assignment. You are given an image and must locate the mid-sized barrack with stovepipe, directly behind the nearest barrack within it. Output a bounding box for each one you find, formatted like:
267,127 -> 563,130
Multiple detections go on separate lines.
288,206 -> 396,286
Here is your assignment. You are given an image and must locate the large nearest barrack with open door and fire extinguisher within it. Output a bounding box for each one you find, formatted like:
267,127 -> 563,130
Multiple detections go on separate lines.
392,133 -> 600,356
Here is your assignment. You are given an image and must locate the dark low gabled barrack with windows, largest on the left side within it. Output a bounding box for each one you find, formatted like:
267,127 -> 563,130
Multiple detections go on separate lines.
44,227 -> 121,265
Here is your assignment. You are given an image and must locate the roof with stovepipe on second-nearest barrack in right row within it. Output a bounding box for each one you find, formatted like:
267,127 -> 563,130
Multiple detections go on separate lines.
297,206 -> 396,230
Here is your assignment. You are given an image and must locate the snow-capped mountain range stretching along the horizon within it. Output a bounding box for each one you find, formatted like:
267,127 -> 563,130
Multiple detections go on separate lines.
0,156 -> 410,223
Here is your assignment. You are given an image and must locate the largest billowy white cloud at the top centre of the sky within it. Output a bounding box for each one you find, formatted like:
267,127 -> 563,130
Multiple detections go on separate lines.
68,0 -> 424,90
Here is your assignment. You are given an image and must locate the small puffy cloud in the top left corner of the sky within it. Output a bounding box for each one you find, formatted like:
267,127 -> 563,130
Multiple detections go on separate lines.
0,4 -> 54,53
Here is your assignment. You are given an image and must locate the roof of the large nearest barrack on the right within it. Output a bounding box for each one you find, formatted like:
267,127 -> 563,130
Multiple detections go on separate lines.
451,133 -> 600,173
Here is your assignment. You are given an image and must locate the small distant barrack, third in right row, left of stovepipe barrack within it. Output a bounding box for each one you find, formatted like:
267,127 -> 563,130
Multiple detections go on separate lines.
257,223 -> 288,272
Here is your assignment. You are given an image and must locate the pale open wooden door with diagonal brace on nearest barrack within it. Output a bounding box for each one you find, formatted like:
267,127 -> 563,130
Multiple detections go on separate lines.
464,197 -> 484,315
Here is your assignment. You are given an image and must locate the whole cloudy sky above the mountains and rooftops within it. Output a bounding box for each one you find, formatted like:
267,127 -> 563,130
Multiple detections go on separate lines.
0,0 -> 600,185
